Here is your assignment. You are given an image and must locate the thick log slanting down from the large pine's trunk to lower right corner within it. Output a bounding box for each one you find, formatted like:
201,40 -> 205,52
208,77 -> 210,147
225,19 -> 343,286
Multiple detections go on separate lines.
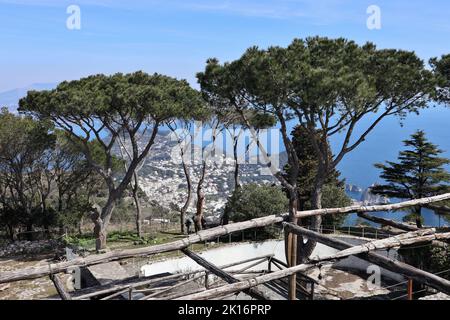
284,224 -> 450,294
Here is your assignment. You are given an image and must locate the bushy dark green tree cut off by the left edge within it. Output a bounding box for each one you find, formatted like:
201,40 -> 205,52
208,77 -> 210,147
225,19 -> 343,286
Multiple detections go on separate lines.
0,108 -> 56,240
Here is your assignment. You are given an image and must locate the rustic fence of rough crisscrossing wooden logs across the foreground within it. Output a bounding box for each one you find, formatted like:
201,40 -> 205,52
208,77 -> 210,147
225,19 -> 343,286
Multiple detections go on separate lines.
0,194 -> 450,300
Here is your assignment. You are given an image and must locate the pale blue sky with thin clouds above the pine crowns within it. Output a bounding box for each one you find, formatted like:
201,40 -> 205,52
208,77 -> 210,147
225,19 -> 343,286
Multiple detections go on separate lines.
0,0 -> 450,92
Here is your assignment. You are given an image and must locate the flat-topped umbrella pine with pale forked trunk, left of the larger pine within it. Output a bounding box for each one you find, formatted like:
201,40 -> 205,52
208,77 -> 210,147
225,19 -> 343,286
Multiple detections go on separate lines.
19,72 -> 204,250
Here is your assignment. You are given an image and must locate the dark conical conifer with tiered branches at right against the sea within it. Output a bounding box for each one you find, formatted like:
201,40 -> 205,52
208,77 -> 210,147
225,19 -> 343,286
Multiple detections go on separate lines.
372,130 -> 450,228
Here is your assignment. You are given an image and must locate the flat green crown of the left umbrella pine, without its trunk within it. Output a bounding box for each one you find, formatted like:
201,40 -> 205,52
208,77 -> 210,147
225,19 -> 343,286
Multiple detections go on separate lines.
20,72 -> 206,123
